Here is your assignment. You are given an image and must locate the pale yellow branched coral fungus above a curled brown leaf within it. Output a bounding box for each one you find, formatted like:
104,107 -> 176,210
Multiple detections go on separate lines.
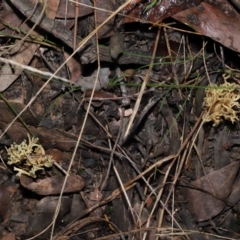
7,135 -> 54,178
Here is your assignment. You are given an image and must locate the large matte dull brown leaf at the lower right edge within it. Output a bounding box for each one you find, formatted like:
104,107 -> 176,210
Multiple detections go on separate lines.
182,162 -> 240,222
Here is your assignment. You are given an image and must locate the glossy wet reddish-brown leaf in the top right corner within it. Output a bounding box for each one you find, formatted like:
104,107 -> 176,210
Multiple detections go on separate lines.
172,0 -> 240,52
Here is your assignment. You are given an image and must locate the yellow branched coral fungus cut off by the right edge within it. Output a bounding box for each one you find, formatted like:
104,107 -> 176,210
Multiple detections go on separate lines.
203,82 -> 240,127
